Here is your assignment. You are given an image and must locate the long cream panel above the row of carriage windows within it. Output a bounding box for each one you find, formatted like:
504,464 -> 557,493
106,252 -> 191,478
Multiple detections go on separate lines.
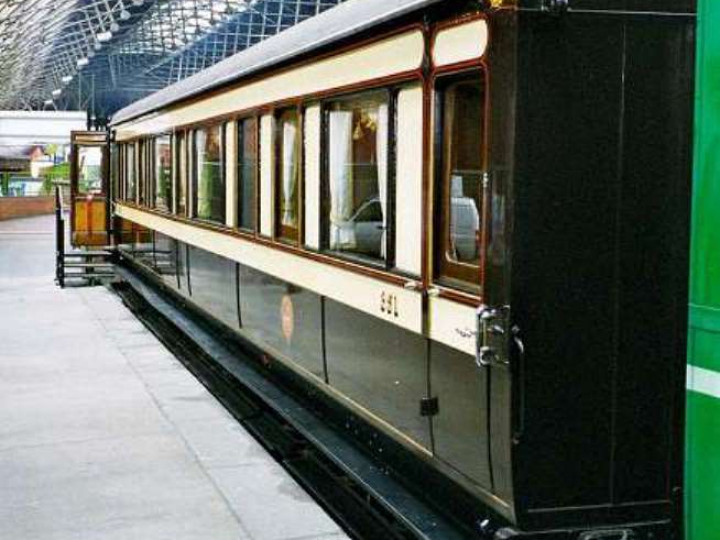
116,30 -> 425,141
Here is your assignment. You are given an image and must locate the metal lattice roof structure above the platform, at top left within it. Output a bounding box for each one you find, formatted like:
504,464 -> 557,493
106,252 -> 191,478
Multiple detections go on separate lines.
0,0 -> 343,113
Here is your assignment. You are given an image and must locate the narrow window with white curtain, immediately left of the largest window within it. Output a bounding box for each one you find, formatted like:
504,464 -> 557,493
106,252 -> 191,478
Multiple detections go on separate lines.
275,109 -> 301,241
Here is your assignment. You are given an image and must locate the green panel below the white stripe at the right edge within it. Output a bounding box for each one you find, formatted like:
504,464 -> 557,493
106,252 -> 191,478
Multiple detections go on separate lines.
685,392 -> 720,540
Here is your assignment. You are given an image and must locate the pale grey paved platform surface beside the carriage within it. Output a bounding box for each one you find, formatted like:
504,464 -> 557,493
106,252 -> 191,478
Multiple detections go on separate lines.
0,216 -> 346,540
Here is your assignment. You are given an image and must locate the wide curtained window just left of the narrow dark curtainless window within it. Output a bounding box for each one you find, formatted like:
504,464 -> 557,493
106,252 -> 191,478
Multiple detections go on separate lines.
194,124 -> 225,224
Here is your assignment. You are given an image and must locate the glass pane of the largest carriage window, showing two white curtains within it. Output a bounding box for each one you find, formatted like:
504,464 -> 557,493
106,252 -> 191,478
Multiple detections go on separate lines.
326,92 -> 388,259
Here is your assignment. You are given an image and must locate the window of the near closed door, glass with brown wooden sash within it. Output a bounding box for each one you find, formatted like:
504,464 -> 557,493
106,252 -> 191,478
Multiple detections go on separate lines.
436,74 -> 485,289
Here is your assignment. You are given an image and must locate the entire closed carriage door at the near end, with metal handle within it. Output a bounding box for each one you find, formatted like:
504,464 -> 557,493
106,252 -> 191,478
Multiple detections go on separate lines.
427,69 -> 509,494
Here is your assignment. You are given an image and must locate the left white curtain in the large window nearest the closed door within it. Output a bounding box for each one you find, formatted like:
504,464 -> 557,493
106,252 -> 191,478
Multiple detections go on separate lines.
329,111 -> 356,249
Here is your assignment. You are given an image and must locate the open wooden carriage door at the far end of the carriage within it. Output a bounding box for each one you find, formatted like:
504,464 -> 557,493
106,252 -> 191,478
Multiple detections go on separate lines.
70,131 -> 109,246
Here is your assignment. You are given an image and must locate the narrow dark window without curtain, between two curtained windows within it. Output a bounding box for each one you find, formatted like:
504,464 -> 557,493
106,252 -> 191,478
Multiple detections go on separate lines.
237,118 -> 258,231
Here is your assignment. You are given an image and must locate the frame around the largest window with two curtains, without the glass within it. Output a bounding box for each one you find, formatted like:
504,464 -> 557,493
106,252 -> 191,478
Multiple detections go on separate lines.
319,84 -> 404,272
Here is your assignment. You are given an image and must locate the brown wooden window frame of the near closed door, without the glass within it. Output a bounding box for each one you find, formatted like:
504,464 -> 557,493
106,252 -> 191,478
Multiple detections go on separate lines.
431,66 -> 489,296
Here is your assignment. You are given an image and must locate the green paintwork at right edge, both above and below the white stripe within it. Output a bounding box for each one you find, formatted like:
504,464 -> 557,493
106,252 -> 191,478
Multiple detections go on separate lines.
686,0 -> 720,540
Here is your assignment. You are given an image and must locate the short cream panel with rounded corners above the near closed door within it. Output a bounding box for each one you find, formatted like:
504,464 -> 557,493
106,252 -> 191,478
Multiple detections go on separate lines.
433,19 -> 488,66
